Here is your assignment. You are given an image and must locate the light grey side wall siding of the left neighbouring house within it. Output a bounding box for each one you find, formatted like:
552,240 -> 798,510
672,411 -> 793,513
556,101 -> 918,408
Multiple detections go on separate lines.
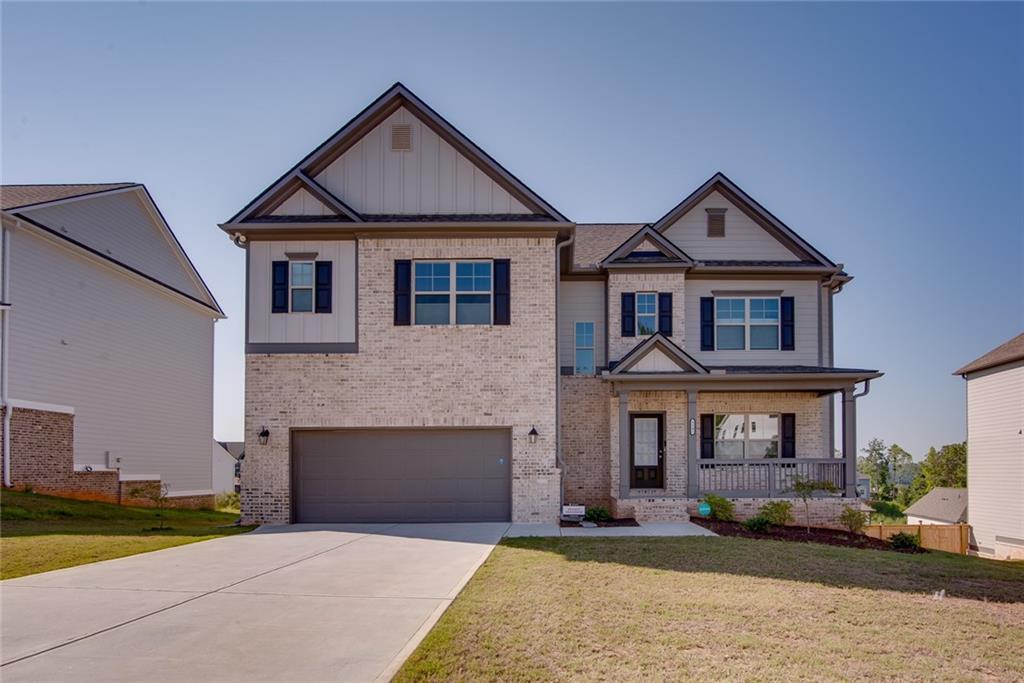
8,229 -> 214,494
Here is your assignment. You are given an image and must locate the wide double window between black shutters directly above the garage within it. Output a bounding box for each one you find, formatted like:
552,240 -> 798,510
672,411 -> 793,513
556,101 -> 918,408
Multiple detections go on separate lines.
414,261 -> 493,325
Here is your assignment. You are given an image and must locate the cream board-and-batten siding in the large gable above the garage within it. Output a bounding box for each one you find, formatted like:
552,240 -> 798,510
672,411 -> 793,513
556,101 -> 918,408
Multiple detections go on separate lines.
315,108 -> 530,214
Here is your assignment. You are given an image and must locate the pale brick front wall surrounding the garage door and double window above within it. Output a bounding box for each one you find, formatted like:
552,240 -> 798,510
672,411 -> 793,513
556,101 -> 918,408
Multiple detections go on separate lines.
242,237 -> 559,523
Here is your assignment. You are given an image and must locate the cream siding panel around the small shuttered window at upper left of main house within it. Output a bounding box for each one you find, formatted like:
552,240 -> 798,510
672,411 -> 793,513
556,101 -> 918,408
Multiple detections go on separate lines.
248,240 -> 356,344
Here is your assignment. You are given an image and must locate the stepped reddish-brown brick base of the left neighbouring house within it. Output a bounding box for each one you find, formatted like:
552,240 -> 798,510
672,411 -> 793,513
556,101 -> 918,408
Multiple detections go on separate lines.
0,407 -> 214,509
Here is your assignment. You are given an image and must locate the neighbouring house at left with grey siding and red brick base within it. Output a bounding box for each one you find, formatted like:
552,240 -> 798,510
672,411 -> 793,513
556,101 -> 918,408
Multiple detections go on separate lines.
0,183 -> 224,506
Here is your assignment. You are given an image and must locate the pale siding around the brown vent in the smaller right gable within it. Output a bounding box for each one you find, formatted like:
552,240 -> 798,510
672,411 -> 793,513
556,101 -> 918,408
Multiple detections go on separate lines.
665,191 -> 800,261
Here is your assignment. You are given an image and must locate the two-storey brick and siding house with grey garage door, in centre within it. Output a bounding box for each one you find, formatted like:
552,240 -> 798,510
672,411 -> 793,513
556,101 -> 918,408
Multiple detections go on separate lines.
221,84 -> 881,524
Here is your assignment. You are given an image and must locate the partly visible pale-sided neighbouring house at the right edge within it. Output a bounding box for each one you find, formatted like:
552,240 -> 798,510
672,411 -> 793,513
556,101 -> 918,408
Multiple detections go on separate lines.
954,334 -> 1024,559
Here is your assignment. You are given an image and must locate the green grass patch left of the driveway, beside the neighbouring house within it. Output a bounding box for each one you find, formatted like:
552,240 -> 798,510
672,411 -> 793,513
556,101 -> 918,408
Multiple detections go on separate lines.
0,490 -> 252,579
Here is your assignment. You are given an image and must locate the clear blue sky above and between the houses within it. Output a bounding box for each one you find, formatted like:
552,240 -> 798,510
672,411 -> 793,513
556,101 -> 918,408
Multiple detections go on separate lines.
0,2 -> 1024,458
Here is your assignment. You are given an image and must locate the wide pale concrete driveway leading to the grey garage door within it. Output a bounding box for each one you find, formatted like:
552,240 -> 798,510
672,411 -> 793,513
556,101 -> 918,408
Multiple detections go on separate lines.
0,523 -> 509,683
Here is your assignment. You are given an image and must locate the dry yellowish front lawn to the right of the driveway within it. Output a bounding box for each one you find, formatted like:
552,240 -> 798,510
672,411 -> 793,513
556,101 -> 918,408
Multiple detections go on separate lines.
395,538 -> 1024,681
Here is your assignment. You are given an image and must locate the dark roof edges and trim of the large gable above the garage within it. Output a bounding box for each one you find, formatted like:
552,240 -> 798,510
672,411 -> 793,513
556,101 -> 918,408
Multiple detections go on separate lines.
222,83 -> 570,224
